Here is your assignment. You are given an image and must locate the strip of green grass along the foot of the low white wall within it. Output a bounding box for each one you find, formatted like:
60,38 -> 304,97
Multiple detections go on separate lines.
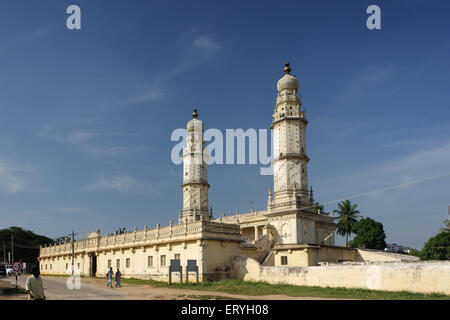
118,279 -> 450,300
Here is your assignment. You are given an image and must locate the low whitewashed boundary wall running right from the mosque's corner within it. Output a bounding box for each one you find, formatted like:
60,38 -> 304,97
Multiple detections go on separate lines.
233,257 -> 450,295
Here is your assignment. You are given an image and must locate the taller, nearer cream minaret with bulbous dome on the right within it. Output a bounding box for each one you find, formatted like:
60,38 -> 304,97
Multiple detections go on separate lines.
269,62 -> 310,209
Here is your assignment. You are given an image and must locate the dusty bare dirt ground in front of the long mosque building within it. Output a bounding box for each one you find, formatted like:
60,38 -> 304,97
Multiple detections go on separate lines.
0,276 -> 342,300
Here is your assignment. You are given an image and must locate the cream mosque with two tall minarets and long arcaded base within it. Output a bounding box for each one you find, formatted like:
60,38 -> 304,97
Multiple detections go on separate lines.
39,63 -> 355,281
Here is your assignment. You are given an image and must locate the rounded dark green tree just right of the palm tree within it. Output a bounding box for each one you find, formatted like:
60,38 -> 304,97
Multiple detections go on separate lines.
352,217 -> 386,250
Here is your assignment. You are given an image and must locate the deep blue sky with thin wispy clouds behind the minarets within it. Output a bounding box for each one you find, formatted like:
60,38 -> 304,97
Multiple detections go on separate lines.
0,0 -> 450,248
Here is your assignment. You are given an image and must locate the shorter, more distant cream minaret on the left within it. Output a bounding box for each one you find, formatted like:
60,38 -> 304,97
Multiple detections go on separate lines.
179,109 -> 209,223
